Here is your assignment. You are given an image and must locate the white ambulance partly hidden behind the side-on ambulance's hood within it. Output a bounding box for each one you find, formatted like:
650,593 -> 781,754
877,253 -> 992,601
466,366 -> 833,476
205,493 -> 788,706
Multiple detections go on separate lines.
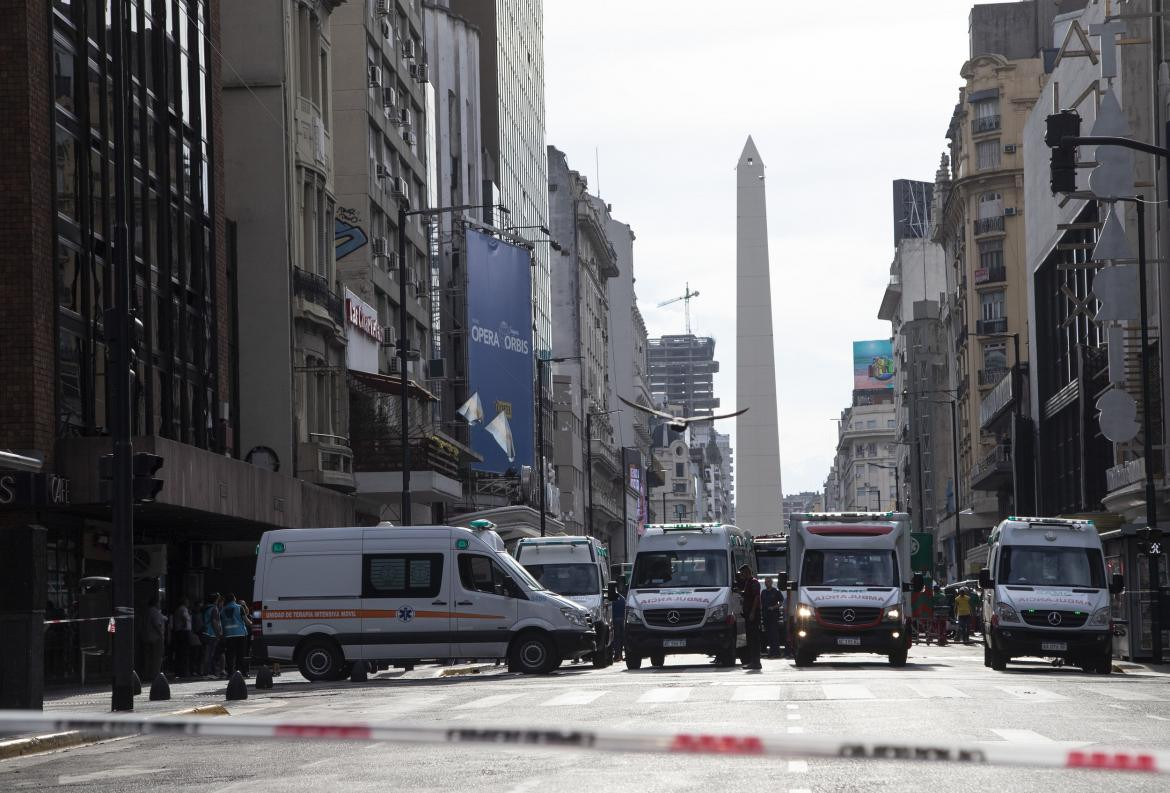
516,537 -> 618,668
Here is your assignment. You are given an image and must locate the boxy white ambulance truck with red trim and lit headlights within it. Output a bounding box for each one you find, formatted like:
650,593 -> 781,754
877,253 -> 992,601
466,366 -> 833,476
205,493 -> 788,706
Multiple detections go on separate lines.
780,512 -> 922,667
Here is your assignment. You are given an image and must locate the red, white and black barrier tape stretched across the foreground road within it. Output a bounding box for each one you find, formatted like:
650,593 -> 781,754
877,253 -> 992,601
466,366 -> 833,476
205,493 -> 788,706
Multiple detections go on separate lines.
0,710 -> 1170,774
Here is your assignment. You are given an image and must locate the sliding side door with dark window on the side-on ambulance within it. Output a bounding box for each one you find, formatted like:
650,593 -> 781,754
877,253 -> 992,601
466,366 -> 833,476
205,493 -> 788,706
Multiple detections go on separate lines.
362,538 -> 452,661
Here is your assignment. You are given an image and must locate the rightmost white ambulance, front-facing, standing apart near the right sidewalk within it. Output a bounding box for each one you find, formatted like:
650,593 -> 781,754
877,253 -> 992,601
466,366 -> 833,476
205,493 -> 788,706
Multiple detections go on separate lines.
979,517 -> 1124,675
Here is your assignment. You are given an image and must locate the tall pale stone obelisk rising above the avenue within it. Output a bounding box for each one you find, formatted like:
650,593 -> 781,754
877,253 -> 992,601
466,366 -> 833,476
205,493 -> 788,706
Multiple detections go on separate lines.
735,136 -> 785,535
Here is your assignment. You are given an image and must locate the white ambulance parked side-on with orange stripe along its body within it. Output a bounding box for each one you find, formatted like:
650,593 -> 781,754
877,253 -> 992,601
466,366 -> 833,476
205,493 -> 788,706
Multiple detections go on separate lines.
255,526 -> 597,681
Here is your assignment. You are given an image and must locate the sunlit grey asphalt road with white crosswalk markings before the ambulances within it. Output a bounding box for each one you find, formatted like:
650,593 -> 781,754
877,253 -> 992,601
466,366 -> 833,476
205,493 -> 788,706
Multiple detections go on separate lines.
0,646 -> 1170,793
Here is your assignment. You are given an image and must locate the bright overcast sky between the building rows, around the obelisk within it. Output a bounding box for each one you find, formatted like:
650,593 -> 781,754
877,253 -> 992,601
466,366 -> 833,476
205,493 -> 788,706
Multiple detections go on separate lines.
544,0 -> 971,494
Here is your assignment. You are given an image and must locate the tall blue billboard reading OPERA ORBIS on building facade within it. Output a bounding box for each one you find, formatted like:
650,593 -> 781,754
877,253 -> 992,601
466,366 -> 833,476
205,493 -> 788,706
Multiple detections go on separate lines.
467,229 -> 535,474
